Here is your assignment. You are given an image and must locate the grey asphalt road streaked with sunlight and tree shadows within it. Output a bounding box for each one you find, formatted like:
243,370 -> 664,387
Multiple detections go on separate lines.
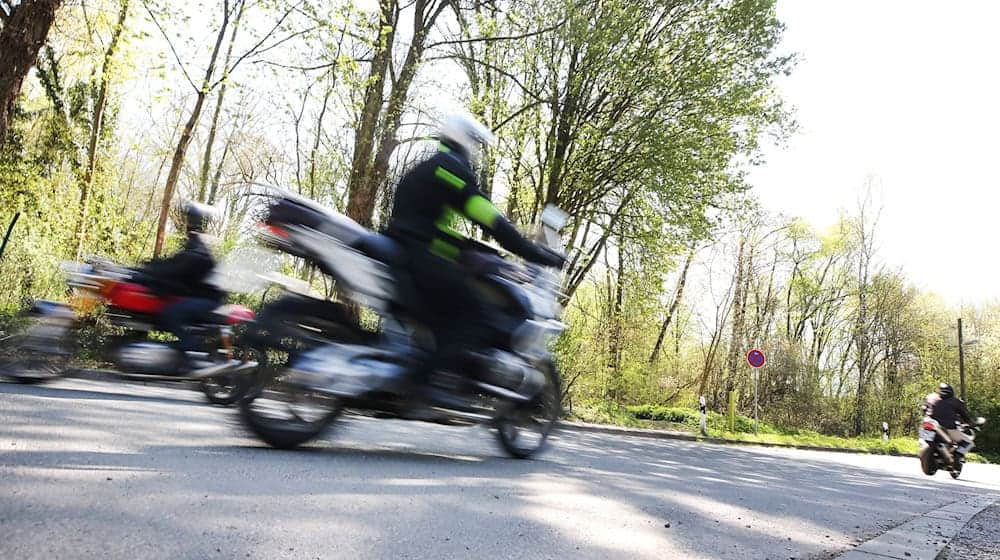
0,380 -> 1000,560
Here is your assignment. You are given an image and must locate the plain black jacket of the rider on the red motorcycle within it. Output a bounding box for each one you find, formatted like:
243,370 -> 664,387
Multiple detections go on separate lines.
143,233 -> 224,300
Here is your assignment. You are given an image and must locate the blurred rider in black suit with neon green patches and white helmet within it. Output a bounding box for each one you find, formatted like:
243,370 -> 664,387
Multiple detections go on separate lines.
388,115 -> 564,419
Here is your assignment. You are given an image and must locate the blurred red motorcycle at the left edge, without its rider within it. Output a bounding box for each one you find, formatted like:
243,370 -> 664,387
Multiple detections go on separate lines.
0,259 -> 259,405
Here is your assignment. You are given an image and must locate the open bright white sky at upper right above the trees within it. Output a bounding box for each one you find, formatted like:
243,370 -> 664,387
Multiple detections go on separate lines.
751,0 -> 1000,303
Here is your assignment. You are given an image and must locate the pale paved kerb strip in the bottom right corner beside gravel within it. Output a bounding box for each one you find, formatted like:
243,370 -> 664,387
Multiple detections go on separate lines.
837,496 -> 995,560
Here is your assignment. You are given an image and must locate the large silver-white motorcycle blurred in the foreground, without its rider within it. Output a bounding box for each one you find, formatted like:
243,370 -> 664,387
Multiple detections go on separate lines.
240,195 -> 567,458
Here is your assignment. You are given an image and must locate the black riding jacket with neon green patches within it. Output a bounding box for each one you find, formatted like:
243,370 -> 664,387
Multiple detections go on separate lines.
389,142 -> 559,266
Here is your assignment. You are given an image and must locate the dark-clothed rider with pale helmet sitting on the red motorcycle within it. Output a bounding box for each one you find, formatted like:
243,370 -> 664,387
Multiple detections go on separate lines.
142,202 -> 225,370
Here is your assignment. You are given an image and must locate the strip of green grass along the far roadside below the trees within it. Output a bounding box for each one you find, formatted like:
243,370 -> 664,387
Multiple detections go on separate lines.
569,401 -> 1000,463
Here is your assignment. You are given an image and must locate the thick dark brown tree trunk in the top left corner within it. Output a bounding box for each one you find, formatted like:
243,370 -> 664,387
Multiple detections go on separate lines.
0,0 -> 62,144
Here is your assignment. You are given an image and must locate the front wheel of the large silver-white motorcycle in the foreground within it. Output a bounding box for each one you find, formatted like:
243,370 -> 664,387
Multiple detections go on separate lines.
495,364 -> 562,459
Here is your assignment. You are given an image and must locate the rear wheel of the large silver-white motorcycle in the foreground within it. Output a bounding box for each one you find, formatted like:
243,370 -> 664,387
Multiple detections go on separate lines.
240,377 -> 344,449
